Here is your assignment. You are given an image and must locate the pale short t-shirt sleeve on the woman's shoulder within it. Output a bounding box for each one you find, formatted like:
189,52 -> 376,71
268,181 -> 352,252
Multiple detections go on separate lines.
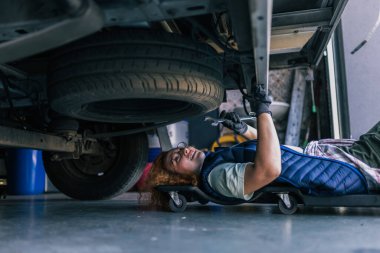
207,163 -> 253,200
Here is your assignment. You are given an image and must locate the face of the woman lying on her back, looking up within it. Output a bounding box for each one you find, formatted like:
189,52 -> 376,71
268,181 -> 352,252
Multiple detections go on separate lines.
165,147 -> 205,175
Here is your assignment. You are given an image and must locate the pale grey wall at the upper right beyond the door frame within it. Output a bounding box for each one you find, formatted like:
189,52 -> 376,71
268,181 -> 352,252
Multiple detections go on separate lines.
342,0 -> 380,138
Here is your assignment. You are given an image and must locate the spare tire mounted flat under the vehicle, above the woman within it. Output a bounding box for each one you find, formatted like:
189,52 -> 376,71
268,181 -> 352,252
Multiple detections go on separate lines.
48,29 -> 224,123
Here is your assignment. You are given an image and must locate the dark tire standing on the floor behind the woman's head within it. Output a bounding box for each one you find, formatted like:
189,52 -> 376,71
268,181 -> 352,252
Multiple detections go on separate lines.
43,133 -> 148,200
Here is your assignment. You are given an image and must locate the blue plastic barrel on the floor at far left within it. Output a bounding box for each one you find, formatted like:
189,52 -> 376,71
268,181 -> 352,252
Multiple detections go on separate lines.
6,149 -> 45,195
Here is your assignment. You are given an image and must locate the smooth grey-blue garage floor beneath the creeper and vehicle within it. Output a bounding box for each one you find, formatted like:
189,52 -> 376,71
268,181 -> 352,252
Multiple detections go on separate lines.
0,193 -> 380,253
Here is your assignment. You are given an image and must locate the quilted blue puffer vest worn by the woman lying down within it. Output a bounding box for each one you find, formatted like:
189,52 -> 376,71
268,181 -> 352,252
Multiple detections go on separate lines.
200,141 -> 368,203
